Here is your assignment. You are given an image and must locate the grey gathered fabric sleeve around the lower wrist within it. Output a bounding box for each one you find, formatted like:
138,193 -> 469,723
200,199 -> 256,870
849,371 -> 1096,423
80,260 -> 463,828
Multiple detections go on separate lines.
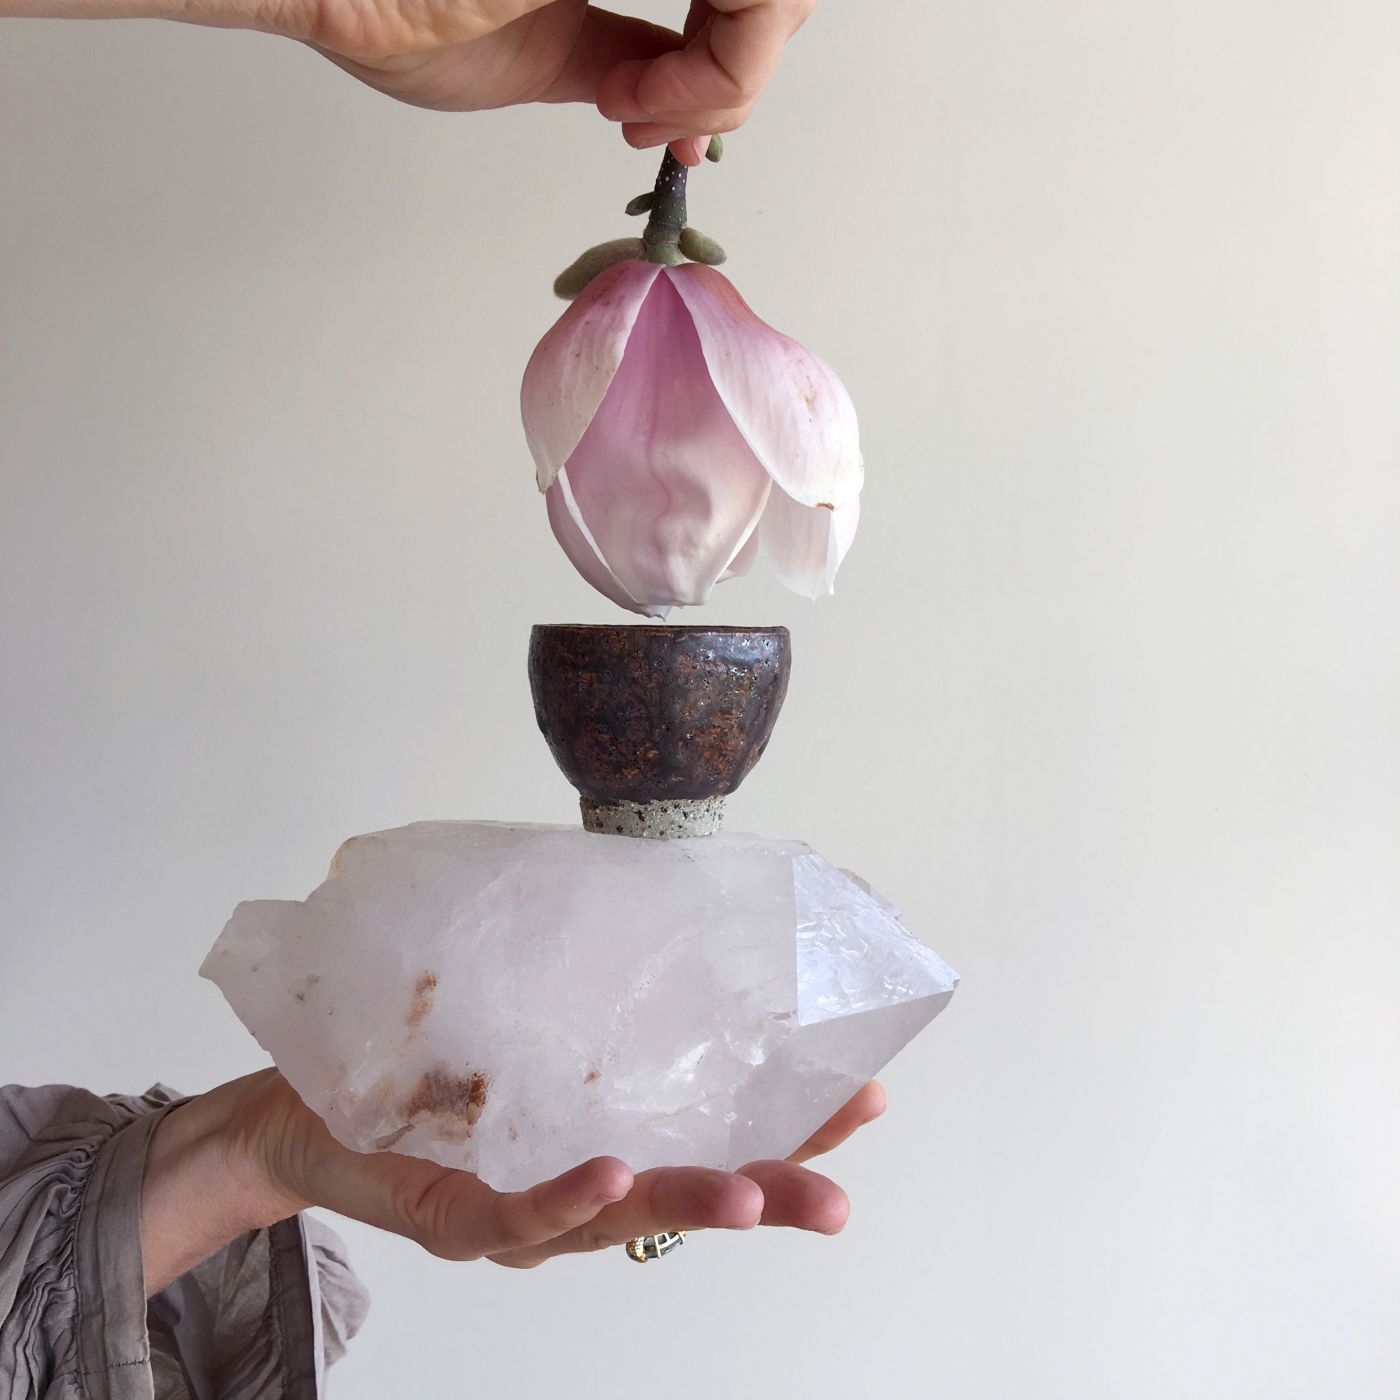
0,1085 -> 368,1400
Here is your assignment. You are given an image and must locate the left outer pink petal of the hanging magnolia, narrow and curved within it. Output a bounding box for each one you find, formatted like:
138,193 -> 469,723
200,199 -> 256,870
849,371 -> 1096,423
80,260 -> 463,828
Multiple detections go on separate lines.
521,260 -> 661,491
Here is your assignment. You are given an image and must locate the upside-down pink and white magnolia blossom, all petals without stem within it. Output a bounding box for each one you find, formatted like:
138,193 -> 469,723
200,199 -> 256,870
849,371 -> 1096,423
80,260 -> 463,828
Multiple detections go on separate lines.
521,258 -> 862,617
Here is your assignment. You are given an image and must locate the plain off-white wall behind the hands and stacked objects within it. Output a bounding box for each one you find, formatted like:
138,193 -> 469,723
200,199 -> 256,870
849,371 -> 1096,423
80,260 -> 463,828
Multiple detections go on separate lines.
0,0 -> 1400,1400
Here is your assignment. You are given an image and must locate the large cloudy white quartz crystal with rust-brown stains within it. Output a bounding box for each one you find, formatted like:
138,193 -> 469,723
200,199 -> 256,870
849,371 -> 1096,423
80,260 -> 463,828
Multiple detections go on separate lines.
200,822 -> 958,1190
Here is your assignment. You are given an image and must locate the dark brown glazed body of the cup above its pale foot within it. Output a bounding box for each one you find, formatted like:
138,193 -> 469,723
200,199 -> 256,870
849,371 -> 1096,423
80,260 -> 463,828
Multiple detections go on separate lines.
529,624 -> 792,806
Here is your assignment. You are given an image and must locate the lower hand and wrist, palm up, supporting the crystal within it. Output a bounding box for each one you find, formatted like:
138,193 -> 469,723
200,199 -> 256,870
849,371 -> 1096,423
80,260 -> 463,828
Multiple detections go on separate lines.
141,1070 -> 885,1294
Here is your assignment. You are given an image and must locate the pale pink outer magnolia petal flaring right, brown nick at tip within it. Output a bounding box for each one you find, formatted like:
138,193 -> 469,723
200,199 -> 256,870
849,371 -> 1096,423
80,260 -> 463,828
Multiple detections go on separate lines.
666,263 -> 864,507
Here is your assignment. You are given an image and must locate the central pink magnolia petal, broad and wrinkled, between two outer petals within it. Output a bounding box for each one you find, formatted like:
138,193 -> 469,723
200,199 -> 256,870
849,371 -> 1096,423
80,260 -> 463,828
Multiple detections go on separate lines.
568,277 -> 773,609
